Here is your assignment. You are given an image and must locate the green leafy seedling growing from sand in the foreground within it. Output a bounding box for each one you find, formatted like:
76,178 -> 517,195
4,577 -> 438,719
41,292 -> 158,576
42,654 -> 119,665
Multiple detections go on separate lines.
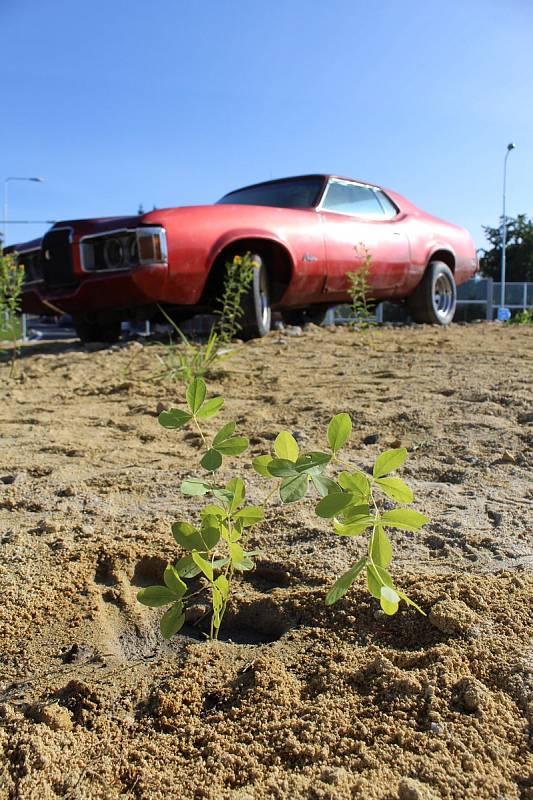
137,378 -> 427,638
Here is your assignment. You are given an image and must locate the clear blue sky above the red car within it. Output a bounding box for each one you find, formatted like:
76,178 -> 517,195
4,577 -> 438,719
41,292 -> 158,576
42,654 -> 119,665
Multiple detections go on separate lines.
0,0 -> 533,246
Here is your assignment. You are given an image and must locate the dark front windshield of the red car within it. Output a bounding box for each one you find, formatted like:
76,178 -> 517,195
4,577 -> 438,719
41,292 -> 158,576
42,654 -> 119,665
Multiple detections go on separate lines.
217,175 -> 324,208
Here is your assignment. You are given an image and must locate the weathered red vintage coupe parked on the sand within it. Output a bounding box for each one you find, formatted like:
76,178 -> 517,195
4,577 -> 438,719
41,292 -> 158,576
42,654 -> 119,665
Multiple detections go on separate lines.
14,175 -> 478,341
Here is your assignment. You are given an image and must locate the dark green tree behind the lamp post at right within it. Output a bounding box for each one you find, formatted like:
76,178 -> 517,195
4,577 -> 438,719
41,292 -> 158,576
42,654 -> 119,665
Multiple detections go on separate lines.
479,214 -> 533,281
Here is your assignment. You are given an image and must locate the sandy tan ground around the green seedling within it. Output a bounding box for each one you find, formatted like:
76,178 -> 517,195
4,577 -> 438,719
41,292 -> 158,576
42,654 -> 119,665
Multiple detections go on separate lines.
0,324 -> 533,800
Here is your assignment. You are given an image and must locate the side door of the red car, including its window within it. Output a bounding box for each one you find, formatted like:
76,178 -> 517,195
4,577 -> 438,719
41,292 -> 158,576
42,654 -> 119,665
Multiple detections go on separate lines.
319,178 -> 411,299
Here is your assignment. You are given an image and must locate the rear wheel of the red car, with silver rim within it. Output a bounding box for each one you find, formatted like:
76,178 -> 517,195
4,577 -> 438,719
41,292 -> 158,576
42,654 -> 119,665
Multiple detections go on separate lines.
407,261 -> 457,325
